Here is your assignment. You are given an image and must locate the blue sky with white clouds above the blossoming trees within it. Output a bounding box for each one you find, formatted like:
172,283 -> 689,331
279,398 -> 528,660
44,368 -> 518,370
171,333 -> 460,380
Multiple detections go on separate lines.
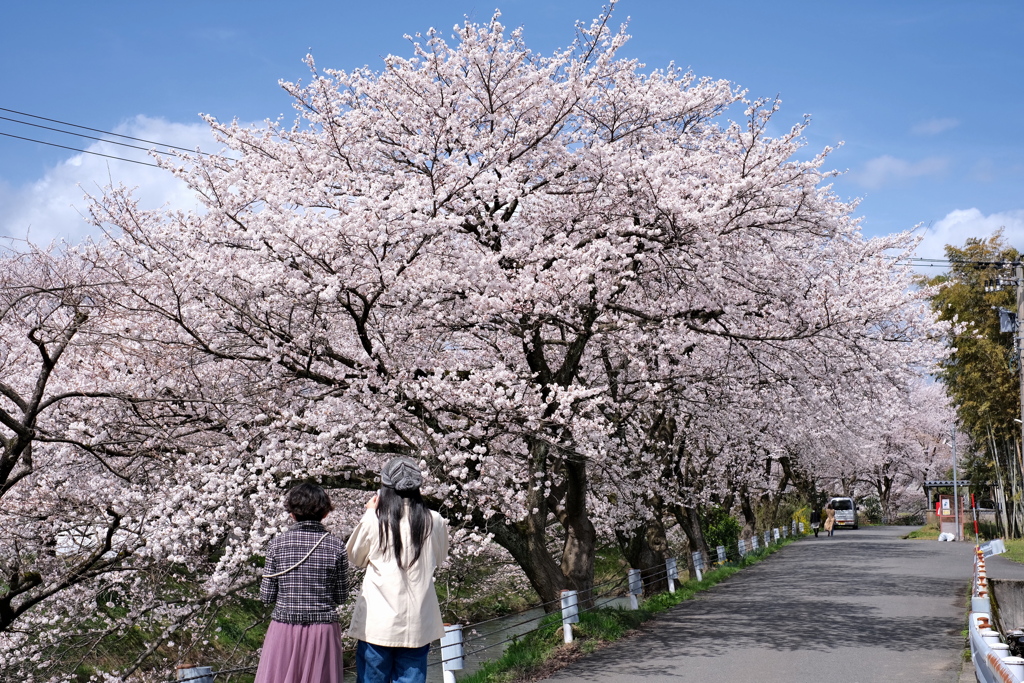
0,0 -> 1024,262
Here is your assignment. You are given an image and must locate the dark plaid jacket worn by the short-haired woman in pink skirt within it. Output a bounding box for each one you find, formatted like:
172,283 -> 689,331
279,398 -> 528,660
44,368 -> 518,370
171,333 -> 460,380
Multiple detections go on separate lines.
259,521 -> 348,624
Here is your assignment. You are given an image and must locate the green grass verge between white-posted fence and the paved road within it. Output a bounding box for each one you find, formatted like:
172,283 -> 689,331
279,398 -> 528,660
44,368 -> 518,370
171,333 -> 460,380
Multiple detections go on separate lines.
460,538 -> 796,683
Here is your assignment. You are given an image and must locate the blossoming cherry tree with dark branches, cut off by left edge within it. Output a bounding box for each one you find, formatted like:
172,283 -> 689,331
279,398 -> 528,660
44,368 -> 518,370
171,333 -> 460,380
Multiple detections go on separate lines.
0,250 -> 195,680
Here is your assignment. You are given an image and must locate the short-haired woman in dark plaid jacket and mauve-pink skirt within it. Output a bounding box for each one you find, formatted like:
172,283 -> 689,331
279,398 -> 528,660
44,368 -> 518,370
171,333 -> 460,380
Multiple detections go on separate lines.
255,483 -> 348,683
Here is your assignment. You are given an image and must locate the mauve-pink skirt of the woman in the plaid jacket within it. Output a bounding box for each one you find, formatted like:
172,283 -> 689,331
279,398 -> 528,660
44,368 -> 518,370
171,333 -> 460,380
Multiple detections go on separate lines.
255,622 -> 342,683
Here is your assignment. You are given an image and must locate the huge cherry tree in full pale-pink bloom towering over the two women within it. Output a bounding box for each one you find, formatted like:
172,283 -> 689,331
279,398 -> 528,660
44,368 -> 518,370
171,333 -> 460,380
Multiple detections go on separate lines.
4,5 -> 936,679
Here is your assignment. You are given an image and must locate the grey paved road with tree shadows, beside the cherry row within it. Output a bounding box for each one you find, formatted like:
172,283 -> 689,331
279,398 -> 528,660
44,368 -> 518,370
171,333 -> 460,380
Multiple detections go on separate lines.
548,527 -> 978,683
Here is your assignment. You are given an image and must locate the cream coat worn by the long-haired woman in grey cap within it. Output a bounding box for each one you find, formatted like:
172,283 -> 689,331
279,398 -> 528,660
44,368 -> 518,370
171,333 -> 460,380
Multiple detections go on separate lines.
346,510 -> 449,647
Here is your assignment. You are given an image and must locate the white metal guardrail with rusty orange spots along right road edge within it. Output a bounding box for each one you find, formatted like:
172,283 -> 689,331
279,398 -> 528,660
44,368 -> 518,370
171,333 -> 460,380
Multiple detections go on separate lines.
968,540 -> 1024,683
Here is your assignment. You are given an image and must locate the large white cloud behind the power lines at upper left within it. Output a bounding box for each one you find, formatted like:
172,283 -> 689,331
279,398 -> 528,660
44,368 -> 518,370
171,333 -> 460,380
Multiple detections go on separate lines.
0,116 -> 219,244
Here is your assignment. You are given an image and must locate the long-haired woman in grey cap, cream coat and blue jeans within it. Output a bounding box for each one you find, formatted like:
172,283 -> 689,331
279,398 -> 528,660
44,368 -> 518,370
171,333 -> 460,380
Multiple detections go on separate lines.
346,458 -> 449,683
